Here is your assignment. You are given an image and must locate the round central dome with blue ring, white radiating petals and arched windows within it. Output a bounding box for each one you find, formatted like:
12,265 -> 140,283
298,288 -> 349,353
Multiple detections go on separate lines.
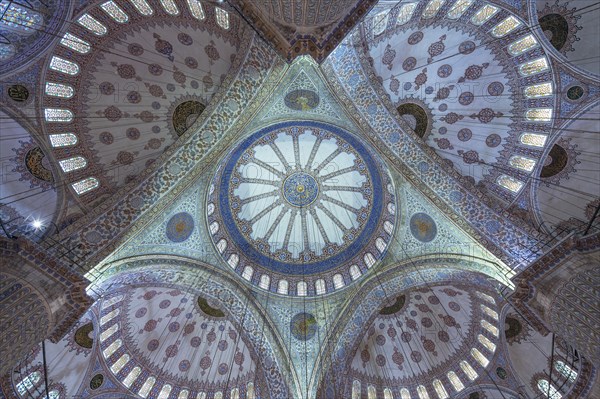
208,122 -> 395,292
